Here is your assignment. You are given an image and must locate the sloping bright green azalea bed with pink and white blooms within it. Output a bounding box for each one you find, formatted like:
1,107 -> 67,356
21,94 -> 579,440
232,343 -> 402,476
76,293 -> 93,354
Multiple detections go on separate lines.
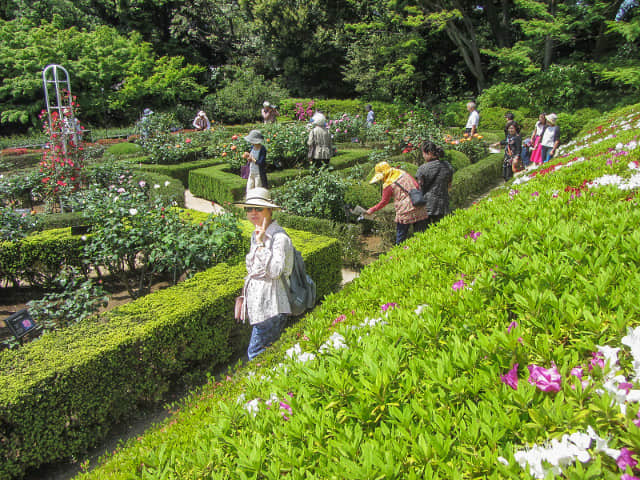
74,107 -> 640,480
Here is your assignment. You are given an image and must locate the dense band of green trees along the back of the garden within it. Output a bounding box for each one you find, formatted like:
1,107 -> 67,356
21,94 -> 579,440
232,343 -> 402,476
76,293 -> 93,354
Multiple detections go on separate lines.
0,0 -> 640,135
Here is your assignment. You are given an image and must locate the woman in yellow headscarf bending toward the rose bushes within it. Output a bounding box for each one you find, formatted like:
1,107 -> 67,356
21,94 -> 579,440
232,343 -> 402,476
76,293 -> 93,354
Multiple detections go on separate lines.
367,162 -> 429,245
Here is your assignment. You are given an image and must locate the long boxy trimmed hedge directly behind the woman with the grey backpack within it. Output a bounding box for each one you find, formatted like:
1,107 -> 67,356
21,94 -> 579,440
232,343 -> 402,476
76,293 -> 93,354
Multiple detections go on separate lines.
0,226 -> 341,478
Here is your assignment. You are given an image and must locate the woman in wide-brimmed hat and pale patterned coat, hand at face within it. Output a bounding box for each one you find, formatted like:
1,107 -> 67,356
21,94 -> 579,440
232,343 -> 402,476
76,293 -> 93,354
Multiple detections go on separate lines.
235,187 -> 293,360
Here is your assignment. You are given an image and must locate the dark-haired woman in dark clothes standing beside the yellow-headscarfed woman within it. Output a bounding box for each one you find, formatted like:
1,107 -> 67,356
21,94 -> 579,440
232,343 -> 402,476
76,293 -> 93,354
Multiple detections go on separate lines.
416,140 -> 453,226
